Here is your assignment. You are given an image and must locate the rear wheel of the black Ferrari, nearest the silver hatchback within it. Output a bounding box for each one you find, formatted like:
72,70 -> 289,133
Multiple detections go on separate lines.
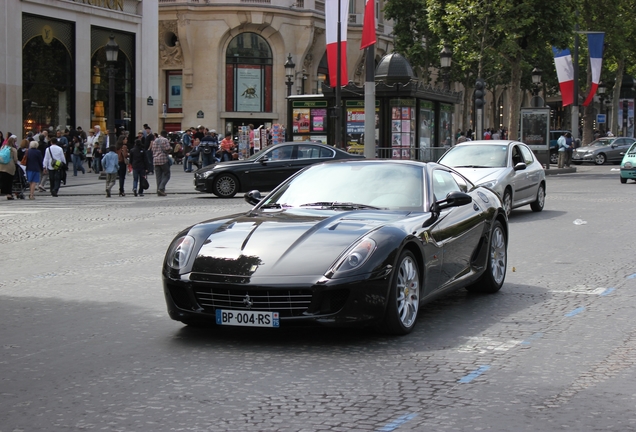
466,221 -> 508,294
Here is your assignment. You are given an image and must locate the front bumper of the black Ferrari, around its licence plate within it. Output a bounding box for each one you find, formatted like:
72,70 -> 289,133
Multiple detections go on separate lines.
163,274 -> 390,327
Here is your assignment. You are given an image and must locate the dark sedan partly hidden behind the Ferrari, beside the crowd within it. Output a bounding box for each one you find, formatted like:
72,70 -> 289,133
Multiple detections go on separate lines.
194,142 -> 363,198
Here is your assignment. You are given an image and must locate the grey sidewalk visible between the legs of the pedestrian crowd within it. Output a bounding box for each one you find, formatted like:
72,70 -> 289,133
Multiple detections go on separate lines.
49,164 -> 201,196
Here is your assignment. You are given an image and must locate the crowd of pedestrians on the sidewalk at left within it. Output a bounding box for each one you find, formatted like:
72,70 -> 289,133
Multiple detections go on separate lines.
0,124 -> 201,200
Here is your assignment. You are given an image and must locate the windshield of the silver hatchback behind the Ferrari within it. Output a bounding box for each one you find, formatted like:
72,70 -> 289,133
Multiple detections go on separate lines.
439,144 -> 508,168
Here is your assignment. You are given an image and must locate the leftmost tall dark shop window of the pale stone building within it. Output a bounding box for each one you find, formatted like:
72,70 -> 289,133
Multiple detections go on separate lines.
22,14 -> 75,136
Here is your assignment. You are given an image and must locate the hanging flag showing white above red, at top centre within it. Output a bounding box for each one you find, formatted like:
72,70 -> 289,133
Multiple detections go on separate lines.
325,0 -> 349,87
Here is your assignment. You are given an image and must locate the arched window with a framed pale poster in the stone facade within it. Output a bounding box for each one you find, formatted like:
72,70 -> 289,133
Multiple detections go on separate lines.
225,33 -> 273,112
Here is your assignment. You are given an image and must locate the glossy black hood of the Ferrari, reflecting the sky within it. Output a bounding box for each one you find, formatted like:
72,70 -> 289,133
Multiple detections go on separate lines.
190,209 -> 408,277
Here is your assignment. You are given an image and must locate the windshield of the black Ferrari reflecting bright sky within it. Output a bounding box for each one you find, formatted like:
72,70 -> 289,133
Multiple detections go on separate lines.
262,163 -> 424,210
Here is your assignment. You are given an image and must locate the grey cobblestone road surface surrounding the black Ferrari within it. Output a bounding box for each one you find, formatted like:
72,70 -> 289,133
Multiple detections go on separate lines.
0,167 -> 636,432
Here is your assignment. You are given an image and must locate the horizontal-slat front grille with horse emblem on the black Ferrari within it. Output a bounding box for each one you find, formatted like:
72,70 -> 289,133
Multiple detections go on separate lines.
194,287 -> 312,318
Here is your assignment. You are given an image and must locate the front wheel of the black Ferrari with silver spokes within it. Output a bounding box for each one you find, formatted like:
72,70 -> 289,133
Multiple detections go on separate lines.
383,250 -> 421,335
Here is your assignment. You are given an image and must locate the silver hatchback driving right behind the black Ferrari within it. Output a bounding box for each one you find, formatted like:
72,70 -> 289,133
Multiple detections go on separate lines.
438,140 -> 546,215
